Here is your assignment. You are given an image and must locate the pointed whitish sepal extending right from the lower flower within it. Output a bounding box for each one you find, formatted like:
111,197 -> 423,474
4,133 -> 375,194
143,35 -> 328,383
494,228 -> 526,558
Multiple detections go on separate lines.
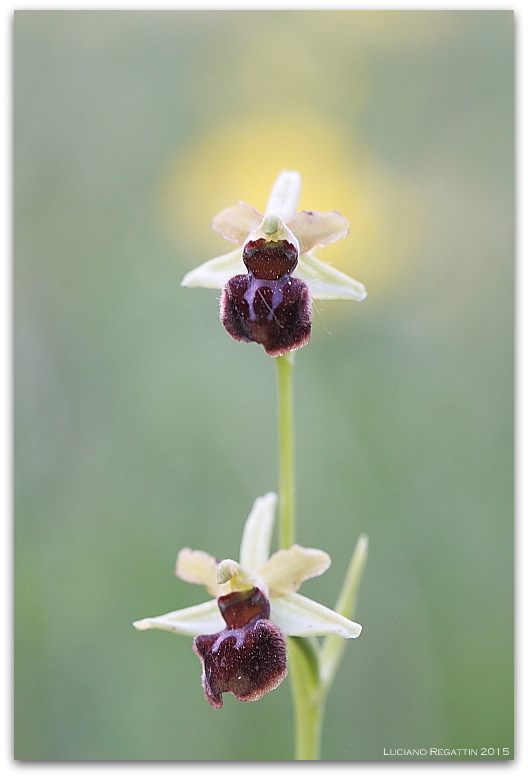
271,592 -> 362,638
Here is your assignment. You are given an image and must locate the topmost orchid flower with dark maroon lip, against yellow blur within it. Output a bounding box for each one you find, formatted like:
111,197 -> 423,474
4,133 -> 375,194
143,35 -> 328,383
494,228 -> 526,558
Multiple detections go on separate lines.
182,170 -> 367,357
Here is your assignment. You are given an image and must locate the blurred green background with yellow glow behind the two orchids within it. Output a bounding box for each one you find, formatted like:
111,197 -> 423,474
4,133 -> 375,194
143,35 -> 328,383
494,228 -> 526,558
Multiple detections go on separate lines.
14,11 -> 514,760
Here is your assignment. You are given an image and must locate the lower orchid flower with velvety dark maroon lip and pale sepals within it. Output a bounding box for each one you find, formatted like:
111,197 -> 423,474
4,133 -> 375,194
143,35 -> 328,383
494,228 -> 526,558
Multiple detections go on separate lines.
134,492 -> 361,708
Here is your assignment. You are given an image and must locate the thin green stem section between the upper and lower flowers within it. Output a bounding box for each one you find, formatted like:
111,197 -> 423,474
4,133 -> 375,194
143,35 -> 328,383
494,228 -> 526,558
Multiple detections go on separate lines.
275,351 -> 295,548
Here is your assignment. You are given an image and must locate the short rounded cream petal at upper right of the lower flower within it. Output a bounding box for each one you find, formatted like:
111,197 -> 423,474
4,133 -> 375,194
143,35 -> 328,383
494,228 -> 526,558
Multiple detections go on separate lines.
259,544 -> 331,597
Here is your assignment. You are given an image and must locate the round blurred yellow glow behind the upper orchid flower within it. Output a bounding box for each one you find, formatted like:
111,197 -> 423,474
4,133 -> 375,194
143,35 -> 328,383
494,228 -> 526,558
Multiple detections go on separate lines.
160,111 -> 421,297
